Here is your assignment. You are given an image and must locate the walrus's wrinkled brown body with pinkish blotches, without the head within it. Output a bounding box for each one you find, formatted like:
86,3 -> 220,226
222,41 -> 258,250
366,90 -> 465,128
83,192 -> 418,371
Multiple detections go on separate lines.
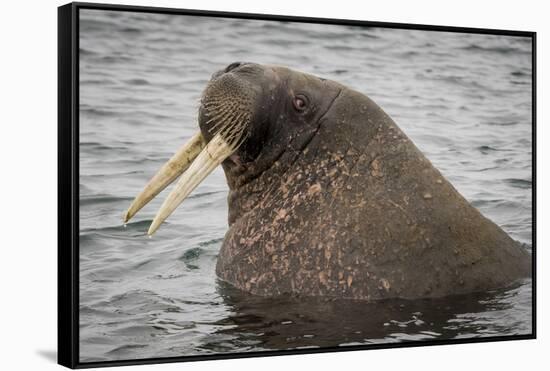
210,65 -> 531,300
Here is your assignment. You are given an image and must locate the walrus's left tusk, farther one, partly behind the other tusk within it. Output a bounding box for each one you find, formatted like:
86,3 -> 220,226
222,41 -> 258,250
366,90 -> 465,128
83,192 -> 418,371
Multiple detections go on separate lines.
123,131 -> 206,223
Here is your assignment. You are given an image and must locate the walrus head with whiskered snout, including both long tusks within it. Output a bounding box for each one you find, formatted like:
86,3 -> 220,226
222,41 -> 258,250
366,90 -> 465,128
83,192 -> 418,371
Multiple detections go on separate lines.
124,62 -> 342,235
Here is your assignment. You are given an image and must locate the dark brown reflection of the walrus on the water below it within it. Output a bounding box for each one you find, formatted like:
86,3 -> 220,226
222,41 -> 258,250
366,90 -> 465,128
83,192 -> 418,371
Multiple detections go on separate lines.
207,280 -> 531,351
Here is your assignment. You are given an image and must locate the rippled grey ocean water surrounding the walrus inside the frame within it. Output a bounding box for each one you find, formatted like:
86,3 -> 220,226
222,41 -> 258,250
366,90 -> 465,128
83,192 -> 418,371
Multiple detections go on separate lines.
79,10 -> 532,362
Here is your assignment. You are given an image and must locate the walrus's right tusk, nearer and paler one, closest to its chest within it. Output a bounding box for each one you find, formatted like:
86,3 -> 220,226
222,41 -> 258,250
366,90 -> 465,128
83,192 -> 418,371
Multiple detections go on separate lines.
147,134 -> 235,236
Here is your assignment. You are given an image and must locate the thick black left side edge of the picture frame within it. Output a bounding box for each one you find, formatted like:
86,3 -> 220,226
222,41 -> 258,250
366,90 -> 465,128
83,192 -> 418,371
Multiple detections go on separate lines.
57,3 -> 78,368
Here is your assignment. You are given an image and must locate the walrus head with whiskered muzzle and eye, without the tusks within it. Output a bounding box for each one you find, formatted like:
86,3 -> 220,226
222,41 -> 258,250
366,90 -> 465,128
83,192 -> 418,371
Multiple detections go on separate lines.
199,62 -> 340,165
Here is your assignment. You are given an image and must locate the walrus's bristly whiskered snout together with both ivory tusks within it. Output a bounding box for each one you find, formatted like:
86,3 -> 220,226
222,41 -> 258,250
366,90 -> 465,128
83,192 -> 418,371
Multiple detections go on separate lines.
123,62 -> 264,235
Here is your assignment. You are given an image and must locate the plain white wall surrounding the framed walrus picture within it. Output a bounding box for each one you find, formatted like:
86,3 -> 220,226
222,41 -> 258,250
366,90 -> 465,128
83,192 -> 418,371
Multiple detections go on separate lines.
0,0 -> 550,371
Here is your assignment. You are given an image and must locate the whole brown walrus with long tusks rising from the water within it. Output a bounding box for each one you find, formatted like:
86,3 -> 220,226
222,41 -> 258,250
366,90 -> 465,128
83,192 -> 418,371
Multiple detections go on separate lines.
124,62 -> 531,301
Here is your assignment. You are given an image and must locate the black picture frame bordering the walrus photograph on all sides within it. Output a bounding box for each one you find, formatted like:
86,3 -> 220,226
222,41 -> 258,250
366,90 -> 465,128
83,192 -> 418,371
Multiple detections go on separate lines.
58,3 -> 537,368
